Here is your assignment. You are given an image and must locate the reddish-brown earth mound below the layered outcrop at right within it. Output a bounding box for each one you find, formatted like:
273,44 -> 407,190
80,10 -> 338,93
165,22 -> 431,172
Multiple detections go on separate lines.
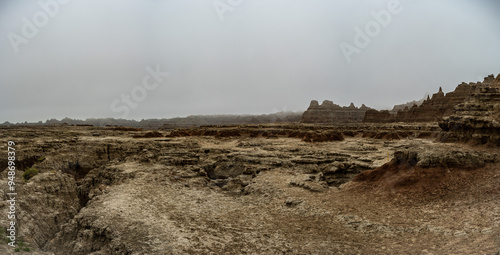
353,149 -> 500,195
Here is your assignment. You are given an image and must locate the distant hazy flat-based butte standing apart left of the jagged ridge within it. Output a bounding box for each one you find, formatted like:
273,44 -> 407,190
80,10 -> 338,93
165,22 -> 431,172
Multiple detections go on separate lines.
300,100 -> 371,124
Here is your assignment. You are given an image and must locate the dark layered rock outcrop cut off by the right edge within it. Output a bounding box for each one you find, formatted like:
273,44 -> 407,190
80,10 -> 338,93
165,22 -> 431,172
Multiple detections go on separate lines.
439,74 -> 500,146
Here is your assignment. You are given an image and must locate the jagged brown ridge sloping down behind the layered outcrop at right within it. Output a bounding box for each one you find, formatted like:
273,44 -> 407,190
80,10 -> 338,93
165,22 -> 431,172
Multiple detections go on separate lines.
363,75 -> 495,123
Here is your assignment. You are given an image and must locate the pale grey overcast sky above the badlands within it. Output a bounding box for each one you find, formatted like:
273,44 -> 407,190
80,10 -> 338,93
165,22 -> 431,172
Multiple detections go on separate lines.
0,0 -> 500,123
